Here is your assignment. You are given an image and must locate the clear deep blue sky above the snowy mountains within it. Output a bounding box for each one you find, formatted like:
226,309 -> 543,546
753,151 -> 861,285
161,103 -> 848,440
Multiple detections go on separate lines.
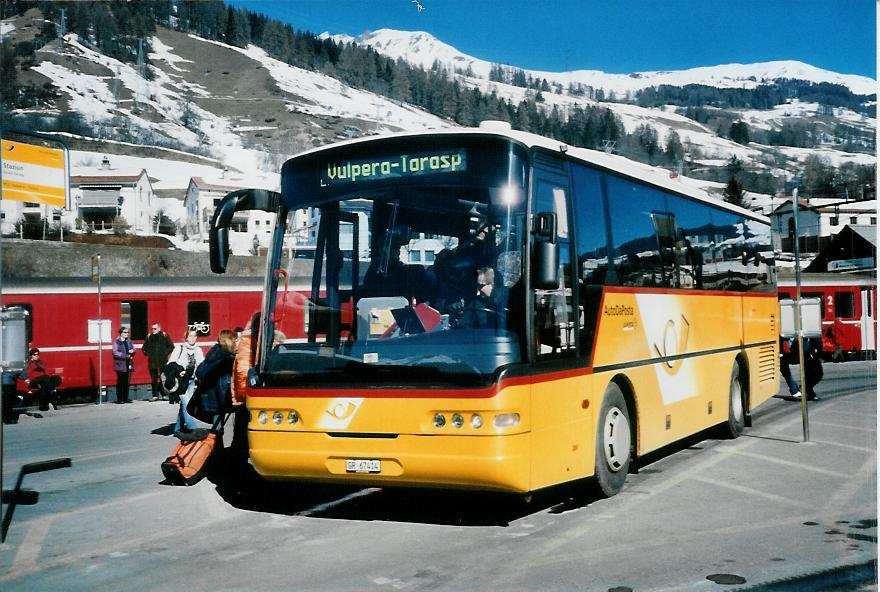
231,0 -> 877,78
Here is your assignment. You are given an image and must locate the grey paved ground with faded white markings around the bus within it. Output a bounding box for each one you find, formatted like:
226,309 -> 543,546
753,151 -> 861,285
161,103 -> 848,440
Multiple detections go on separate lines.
0,362 -> 877,592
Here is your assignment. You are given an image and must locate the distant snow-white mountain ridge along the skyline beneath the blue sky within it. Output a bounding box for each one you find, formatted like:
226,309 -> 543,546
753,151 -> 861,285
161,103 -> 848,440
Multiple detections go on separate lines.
338,29 -> 877,96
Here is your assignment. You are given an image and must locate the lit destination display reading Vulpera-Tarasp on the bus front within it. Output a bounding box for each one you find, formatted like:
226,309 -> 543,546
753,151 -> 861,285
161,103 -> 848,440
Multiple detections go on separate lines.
321,148 -> 467,187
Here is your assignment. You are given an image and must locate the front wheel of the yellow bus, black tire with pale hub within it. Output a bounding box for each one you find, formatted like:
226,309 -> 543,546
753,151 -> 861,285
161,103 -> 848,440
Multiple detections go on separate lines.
596,382 -> 633,497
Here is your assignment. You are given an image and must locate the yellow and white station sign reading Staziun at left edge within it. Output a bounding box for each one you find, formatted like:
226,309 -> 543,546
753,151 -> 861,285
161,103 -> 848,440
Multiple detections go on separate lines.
0,140 -> 70,208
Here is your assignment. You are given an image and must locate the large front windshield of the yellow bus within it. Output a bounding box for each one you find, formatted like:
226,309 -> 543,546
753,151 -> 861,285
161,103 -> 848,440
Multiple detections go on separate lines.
262,139 -> 526,386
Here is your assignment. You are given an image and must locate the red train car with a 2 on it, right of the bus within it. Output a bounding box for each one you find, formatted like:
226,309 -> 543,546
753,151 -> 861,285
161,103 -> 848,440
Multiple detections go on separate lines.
778,273 -> 877,359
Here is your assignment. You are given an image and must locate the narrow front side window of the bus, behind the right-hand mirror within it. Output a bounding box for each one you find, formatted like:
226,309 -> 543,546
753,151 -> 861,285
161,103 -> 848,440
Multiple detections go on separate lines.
533,169 -> 577,359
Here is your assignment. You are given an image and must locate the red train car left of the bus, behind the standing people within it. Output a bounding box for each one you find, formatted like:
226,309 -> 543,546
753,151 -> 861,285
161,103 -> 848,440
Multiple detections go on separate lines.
3,277 -> 272,393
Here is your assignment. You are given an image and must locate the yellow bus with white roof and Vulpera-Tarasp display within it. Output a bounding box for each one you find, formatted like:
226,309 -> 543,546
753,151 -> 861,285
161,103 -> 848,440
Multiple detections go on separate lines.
211,122 -> 778,496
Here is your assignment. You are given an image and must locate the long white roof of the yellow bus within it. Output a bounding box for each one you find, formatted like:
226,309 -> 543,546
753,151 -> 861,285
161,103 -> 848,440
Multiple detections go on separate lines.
290,121 -> 770,224
